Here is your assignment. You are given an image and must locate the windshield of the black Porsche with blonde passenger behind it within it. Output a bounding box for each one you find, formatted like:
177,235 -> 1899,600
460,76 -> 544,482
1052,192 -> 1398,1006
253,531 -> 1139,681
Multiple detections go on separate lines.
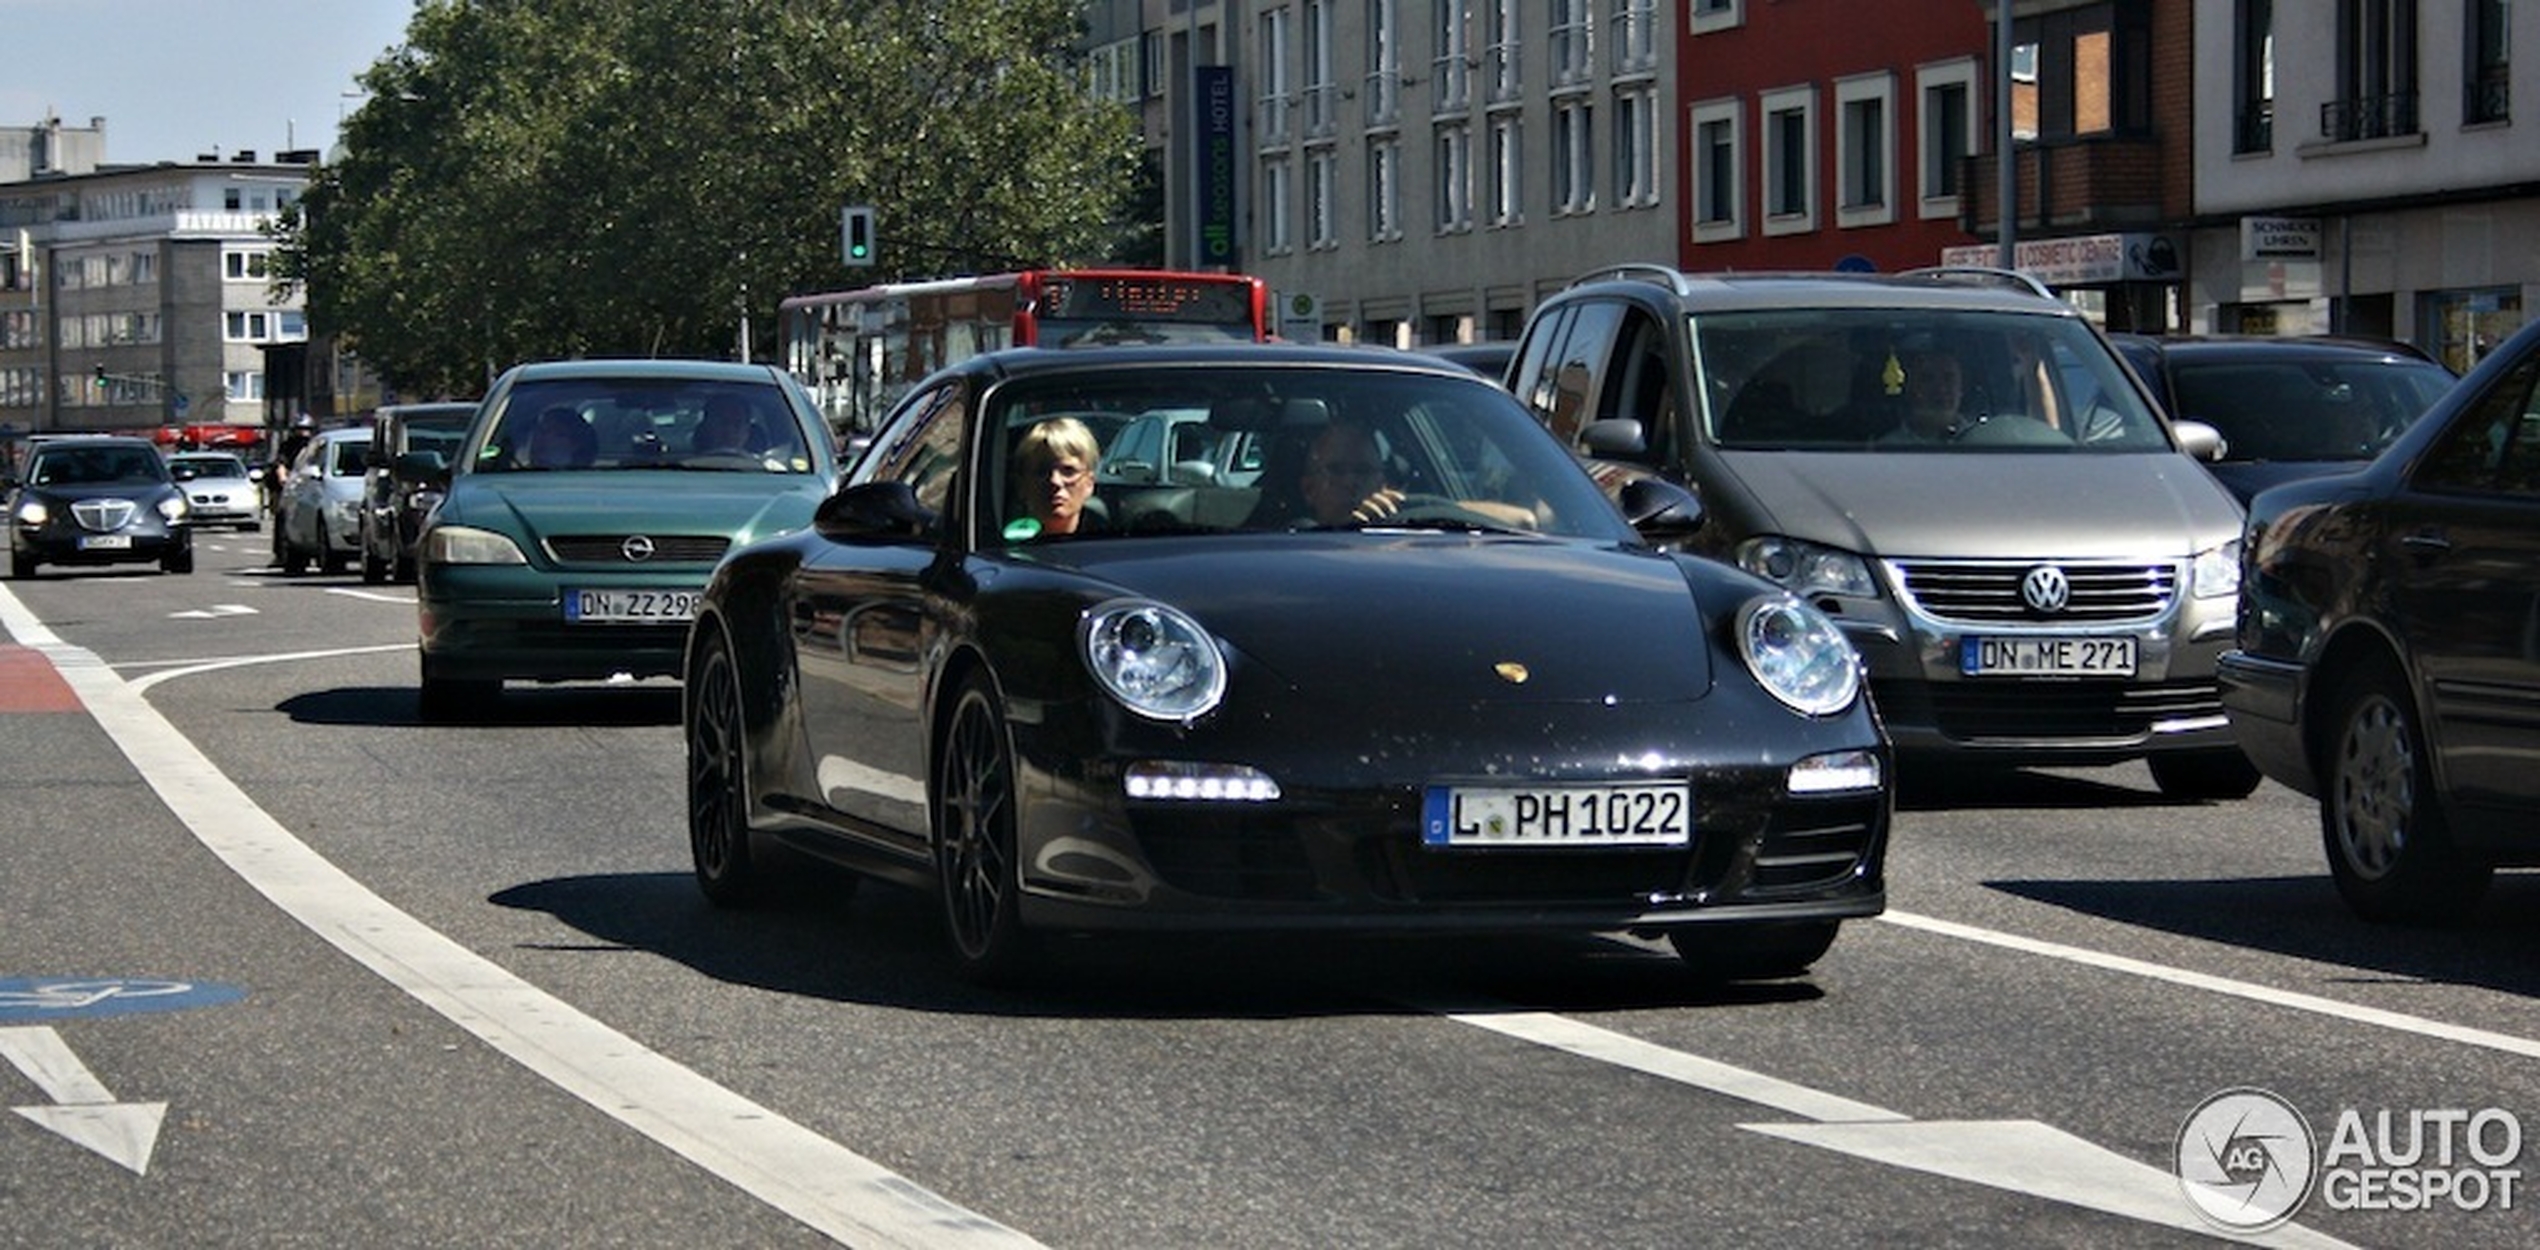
980,366 -> 1631,544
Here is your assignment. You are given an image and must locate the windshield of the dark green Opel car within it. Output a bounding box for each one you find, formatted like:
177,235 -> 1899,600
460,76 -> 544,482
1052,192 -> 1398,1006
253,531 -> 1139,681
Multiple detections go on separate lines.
475,379 -> 813,473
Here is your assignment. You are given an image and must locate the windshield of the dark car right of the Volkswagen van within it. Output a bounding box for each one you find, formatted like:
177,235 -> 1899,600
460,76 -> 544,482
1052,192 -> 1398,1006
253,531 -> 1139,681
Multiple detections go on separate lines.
2172,358 -> 2454,460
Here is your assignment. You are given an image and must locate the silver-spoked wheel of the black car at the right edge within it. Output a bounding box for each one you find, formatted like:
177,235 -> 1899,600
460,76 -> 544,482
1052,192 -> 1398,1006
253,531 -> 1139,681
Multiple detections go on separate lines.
2319,661 -> 2494,925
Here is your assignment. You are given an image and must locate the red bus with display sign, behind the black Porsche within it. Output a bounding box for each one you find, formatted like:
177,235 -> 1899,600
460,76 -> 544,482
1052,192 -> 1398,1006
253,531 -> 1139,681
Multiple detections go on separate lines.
777,269 -> 1270,440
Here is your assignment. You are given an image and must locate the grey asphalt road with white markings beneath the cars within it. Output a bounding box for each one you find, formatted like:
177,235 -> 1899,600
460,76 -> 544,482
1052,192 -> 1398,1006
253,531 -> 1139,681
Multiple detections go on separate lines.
0,534 -> 2540,1250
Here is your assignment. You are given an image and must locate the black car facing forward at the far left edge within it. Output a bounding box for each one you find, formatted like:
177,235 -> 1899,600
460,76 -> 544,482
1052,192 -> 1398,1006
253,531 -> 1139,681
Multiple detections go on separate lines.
8,434 -> 193,577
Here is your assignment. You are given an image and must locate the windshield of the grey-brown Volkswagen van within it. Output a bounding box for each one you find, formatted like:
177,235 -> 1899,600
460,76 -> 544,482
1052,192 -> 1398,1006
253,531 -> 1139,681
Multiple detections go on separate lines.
1692,307 -> 2169,455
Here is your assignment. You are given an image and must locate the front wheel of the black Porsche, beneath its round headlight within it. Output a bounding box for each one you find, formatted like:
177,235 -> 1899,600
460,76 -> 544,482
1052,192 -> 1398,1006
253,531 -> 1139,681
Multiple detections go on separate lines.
935,673 -> 1031,983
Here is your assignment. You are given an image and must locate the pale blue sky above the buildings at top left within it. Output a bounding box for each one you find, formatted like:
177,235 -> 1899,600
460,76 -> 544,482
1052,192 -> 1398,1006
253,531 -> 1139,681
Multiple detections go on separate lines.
0,0 -> 414,165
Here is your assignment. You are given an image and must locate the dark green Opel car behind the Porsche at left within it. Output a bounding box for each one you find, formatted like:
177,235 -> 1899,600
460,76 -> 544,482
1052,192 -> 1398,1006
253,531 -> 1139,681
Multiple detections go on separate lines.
411,361 -> 838,722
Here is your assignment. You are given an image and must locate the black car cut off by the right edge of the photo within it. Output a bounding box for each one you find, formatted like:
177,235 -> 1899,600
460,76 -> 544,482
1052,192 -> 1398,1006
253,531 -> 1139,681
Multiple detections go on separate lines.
2220,323 -> 2540,920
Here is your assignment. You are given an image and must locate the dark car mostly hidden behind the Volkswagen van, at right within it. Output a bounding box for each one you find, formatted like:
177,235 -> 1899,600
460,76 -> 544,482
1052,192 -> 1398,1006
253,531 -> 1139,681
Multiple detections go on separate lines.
2108,335 -> 2456,503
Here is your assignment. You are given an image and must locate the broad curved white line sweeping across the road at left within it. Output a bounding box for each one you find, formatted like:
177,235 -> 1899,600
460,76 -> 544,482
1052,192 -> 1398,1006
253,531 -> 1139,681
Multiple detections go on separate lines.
0,587 -> 1039,1250
